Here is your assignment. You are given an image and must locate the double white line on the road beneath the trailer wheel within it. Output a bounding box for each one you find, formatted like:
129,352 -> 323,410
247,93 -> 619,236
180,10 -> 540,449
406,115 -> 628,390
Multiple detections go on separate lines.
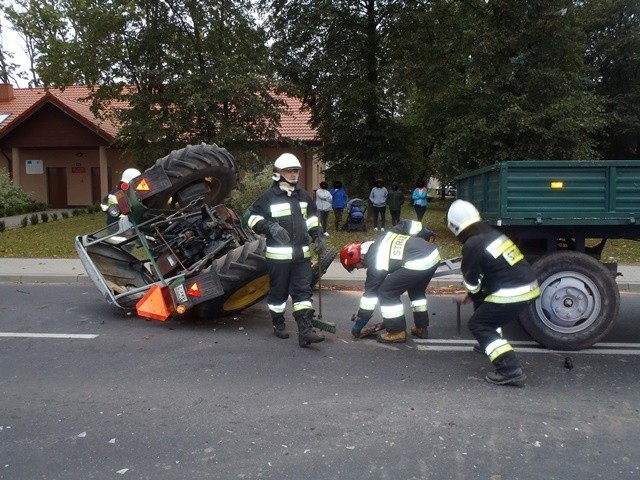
414,339 -> 640,355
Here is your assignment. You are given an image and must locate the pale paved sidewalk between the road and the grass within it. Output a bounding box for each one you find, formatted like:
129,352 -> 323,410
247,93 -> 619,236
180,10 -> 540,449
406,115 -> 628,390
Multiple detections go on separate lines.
0,258 -> 640,292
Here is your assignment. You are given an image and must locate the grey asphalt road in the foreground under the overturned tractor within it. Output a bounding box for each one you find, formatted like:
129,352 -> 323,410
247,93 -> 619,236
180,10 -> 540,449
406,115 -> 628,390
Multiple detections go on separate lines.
0,284 -> 640,480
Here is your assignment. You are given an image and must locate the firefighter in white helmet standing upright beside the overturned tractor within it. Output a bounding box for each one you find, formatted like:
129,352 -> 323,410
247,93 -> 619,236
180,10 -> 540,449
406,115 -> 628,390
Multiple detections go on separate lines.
247,153 -> 324,347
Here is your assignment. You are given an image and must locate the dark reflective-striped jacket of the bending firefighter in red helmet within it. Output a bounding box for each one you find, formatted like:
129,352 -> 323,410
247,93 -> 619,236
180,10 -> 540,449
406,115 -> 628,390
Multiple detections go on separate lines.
362,232 -> 440,296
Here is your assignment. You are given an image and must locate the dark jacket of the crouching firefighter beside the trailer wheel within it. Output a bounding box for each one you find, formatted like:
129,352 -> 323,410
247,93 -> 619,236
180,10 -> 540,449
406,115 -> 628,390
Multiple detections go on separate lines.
461,222 -> 540,303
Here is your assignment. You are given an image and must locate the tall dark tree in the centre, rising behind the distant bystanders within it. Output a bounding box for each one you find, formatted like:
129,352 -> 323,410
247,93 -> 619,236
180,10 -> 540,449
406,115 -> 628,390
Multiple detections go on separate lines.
262,0 -> 424,195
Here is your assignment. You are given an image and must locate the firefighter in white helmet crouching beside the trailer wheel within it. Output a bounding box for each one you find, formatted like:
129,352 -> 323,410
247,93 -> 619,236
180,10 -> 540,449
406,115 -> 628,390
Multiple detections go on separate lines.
447,200 -> 540,386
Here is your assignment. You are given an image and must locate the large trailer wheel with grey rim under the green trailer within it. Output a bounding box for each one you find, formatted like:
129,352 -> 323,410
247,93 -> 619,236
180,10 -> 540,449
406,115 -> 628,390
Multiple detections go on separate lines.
520,251 -> 620,350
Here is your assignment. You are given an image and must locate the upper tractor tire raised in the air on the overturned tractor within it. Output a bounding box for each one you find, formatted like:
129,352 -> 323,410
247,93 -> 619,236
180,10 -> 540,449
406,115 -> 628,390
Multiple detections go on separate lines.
144,143 -> 240,209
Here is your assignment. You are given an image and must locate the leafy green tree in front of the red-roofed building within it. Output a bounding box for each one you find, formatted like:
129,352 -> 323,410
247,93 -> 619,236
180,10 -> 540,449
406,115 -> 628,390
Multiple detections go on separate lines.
6,0 -> 282,167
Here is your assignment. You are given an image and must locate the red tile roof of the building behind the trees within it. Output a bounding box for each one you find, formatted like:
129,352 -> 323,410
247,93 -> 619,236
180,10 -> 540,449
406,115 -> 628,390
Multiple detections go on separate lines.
0,84 -> 317,142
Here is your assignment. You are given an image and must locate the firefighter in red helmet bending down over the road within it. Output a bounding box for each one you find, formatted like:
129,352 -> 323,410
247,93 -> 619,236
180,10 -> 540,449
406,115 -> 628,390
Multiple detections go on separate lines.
340,220 -> 440,343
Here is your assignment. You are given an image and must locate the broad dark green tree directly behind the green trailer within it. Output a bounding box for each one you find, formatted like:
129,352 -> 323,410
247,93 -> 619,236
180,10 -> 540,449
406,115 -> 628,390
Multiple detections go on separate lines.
407,0 -> 606,184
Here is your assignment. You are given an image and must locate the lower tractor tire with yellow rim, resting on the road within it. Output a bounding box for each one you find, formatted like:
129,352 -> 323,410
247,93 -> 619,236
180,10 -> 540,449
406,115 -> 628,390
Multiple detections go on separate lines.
196,237 -> 269,318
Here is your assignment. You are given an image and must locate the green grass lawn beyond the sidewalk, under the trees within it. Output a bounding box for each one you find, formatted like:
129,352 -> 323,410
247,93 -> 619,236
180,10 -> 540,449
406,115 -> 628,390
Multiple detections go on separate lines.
0,198 -> 640,264
